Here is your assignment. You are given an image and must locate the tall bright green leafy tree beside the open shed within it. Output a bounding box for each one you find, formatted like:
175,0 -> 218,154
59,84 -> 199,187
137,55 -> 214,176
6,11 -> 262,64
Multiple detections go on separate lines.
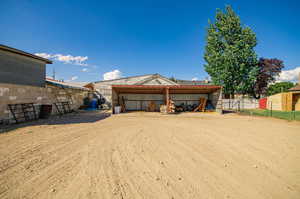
204,6 -> 258,96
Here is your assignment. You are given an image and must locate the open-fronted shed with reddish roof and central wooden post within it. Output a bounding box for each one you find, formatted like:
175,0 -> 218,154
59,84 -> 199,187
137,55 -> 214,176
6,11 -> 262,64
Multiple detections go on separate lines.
112,85 -> 222,112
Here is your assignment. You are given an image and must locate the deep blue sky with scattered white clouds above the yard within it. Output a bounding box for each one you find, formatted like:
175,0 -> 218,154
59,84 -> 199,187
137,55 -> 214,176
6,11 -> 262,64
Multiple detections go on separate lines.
0,0 -> 300,82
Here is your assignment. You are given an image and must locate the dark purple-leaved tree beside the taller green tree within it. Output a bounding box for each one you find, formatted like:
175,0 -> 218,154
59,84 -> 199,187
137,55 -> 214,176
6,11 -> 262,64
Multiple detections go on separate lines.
250,58 -> 284,99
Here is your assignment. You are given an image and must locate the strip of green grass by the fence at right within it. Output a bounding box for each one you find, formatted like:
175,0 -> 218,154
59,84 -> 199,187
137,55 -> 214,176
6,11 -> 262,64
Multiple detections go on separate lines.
240,109 -> 300,121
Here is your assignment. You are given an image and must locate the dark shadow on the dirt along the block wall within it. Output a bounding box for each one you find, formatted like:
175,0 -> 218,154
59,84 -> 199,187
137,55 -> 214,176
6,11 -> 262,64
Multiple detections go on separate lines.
0,111 -> 111,133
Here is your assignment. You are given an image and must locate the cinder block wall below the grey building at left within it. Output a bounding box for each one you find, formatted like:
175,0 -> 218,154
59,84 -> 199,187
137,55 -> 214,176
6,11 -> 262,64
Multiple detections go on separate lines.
0,84 -> 88,123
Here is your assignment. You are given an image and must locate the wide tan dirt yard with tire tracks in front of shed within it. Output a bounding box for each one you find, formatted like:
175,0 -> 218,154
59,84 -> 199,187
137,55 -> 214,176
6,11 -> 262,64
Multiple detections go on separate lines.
0,112 -> 300,199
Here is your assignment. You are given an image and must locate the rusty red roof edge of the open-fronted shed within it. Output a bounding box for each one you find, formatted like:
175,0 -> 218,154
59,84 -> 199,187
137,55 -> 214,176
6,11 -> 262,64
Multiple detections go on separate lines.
112,85 -> 222,94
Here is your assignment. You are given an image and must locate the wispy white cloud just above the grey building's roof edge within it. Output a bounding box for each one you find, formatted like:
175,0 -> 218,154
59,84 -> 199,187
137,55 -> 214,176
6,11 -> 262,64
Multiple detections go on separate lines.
35,53 -> 88,66
